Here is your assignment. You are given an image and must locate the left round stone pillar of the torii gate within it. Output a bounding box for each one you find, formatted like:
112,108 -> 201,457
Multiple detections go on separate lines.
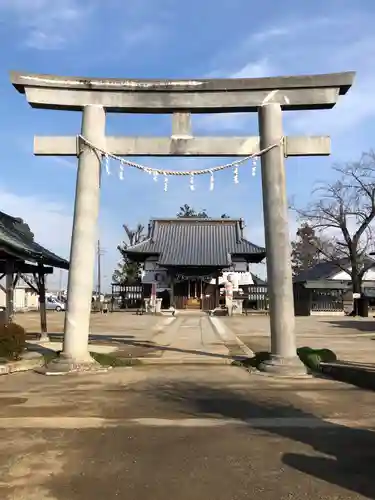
61,105 -> 105,371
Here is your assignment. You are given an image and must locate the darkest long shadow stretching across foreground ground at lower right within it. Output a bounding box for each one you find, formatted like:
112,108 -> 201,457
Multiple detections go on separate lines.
145,383 -> 375,498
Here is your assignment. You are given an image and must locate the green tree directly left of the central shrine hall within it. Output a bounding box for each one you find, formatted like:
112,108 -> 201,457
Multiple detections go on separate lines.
112,224 -> 146,285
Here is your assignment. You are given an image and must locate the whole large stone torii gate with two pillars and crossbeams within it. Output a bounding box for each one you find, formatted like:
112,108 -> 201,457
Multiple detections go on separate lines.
11,72 -> 355,374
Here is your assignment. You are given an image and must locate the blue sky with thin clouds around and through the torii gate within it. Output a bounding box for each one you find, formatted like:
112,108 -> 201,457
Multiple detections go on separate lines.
0,0 -> 375,290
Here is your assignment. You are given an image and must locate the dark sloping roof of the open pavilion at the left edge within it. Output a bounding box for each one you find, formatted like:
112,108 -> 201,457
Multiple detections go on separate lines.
0,212 -> 69,269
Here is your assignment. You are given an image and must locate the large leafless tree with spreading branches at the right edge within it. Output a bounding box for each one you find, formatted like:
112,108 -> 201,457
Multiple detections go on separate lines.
292,151 -> 375,293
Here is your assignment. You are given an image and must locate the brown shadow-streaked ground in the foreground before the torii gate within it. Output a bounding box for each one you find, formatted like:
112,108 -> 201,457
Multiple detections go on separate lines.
0,365 -> 375,500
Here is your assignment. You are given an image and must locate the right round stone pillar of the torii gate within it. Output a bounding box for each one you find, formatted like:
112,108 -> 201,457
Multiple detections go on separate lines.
258,103 -> 304,374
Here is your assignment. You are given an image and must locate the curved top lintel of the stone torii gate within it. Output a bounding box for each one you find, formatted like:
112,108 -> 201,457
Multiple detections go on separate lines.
11,71 -> 355,113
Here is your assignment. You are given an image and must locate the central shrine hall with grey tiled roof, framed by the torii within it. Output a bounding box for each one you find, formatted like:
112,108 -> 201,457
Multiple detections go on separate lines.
126,217 -> 266,310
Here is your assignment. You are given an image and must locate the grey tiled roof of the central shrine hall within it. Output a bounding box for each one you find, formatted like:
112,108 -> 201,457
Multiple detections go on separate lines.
126,218 -> 266,268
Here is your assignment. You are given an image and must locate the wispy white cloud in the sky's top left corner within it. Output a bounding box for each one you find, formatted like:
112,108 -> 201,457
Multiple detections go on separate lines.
0,0 -> 90,50
